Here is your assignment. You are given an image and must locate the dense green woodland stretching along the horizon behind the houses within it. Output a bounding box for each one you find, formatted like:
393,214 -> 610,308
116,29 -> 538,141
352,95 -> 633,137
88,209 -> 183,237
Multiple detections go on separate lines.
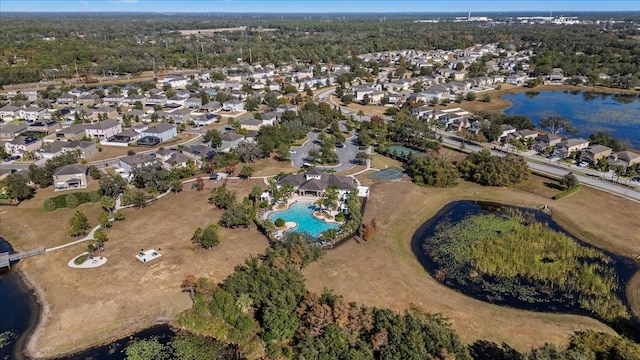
0,14 -> 640,87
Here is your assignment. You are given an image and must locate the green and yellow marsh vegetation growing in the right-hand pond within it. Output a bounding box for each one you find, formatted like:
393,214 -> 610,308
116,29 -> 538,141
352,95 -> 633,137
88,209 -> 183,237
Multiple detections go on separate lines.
419,202 -> 630,330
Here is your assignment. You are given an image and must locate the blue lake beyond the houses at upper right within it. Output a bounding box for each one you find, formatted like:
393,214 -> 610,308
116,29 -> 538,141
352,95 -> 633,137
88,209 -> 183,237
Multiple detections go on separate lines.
502,91 -> 640,149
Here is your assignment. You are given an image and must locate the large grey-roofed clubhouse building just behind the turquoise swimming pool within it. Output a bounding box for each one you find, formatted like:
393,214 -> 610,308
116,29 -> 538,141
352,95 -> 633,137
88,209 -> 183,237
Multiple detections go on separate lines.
277,168 -> 356,197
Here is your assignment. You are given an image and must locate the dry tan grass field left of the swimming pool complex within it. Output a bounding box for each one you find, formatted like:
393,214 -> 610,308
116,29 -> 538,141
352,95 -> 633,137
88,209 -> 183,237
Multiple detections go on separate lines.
1,180 -> 268,356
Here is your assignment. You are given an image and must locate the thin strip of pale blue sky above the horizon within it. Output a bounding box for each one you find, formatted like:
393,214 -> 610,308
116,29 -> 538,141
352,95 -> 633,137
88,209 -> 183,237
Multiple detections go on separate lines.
0,0 -> 640,14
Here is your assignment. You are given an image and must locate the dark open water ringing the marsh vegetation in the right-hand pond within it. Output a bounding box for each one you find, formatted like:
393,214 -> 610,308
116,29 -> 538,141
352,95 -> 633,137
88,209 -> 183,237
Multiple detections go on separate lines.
411,201 -> 640,329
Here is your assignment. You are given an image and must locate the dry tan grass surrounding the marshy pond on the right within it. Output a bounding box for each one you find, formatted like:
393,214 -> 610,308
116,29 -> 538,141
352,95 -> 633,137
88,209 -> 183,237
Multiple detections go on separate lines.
304,177 -> 640,351
